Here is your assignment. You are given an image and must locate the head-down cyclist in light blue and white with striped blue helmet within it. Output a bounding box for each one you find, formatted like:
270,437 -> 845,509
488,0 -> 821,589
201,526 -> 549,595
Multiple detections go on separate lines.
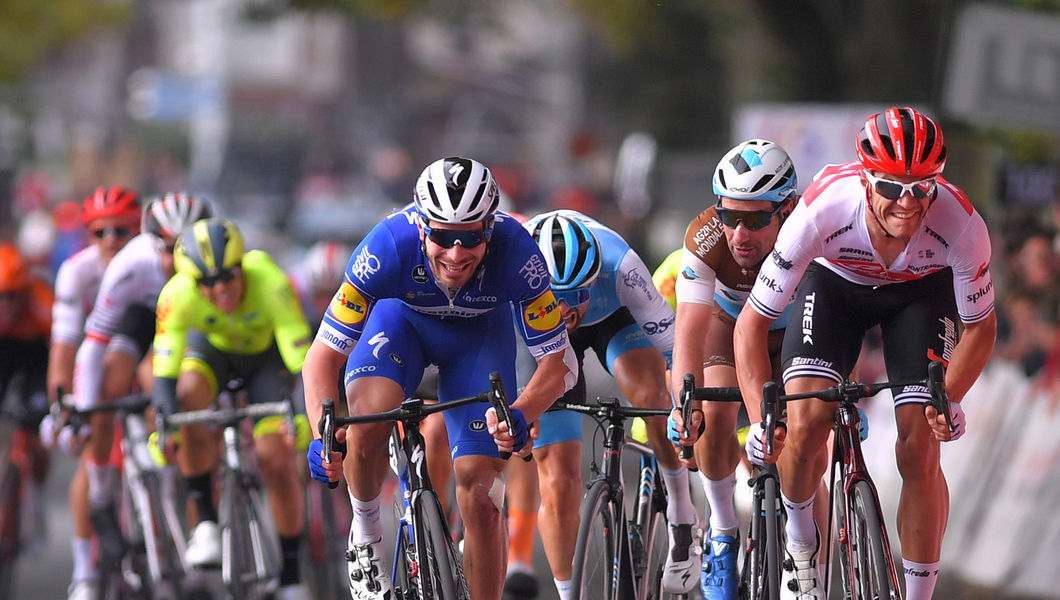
526,210 -> 700,599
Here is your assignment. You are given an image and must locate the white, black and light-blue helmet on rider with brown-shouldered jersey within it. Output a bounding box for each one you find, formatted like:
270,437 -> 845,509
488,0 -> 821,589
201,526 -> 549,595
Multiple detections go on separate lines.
713,139 -> 798,204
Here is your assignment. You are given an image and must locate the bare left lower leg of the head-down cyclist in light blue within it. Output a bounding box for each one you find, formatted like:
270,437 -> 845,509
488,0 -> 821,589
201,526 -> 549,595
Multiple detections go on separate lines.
534,440 -> 582,581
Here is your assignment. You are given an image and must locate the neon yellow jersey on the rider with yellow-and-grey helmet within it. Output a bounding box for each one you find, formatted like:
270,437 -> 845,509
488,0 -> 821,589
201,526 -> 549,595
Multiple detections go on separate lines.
154,250 -> 312,378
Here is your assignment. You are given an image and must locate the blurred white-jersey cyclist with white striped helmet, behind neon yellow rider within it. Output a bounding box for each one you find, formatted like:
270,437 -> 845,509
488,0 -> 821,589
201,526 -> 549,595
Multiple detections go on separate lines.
73,193 -> 213,572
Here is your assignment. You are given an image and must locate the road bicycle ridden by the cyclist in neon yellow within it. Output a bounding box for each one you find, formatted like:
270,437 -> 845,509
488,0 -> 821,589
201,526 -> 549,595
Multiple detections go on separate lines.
159,390 -> 295,600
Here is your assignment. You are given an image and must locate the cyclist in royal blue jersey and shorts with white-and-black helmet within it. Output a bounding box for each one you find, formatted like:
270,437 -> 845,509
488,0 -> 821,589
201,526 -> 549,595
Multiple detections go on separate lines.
302,158 -> 578,599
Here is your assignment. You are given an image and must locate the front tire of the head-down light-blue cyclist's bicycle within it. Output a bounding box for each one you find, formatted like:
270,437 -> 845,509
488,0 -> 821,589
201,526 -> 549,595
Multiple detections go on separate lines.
570,479 -> 622,600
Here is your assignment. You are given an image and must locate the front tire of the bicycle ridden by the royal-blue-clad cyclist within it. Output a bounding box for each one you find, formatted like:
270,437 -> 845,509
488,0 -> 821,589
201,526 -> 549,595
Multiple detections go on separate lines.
412,490 -> 470,600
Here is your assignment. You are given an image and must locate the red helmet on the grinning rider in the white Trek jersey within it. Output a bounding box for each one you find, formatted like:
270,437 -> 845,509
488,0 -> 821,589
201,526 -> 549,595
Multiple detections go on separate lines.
858,106 -> 946,177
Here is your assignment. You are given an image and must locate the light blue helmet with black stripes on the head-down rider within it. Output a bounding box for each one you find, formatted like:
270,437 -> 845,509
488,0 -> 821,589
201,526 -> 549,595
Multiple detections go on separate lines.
527,211 -> 603,292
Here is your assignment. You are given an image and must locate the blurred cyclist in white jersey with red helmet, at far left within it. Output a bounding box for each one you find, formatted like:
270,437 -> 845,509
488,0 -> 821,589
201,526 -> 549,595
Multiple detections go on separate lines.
41,186 -> 140,600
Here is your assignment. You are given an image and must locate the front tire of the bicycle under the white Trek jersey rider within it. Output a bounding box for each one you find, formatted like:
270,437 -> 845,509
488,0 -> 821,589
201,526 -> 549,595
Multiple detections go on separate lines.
847,480 -> 891,600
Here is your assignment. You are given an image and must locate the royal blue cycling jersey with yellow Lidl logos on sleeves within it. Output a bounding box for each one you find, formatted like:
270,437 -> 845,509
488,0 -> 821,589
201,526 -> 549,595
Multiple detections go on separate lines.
317,204 -> 566,357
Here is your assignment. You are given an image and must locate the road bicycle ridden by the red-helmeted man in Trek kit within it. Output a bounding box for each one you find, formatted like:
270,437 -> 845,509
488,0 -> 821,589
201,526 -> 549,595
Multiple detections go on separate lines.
762,361 -> 954,600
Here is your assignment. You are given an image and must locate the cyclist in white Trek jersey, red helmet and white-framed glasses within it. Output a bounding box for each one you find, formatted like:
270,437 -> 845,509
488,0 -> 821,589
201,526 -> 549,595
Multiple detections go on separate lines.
735,107 -> 996,600
